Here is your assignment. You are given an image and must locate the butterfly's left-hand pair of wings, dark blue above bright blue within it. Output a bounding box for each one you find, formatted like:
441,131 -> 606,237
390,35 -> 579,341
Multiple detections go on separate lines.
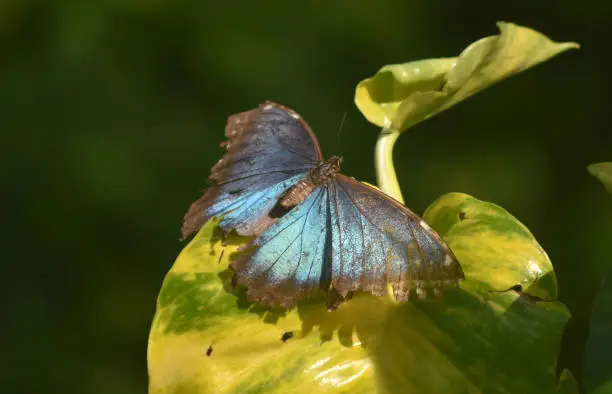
182,101 -> 322,238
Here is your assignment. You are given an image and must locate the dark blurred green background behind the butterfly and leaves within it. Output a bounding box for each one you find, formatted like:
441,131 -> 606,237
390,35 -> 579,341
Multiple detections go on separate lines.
0,0 -> 612,394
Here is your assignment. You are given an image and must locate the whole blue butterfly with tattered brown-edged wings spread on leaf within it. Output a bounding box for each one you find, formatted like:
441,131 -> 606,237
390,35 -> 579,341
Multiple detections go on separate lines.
182,101 -> 464,307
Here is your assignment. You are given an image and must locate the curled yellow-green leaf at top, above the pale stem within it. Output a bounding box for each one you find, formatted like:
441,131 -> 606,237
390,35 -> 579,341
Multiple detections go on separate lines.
355,22 -> 579,131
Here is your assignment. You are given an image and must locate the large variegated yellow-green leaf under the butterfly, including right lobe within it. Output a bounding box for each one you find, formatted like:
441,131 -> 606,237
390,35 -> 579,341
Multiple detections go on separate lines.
148,193 -> 569,394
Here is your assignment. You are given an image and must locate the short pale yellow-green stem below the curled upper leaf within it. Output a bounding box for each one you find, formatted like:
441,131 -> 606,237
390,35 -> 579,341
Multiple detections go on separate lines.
374,127 -> 404,204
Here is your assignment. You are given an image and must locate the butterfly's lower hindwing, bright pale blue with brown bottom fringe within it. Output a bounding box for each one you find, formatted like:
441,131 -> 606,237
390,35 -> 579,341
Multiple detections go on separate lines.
232,187 -> 331,308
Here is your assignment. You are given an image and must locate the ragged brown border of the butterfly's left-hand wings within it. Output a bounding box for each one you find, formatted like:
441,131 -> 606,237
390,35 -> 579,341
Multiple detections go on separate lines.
181,100 -> 323,241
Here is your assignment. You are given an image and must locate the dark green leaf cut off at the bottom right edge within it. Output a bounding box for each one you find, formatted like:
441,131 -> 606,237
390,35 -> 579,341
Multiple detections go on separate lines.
584,272 -> 612,394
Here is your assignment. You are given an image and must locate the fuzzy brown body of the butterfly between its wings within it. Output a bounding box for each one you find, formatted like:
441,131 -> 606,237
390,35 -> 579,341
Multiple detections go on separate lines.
279,156 -> 342,208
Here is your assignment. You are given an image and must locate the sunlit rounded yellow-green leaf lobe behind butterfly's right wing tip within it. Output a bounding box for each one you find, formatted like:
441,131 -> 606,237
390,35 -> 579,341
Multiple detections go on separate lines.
425,193 -> 557,300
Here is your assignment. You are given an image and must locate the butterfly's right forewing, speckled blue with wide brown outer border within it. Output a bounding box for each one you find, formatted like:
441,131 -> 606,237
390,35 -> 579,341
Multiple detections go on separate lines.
328,174 -> 463,301
